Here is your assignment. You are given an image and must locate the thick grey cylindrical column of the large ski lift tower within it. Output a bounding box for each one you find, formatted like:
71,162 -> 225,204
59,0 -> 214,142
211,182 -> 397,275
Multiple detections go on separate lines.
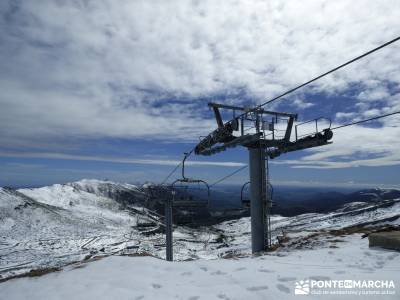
249,147 -> 266,253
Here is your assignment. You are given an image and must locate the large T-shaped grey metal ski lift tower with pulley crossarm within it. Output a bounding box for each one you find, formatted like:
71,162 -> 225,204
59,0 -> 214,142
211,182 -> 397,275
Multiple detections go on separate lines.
194,103 -> 333,253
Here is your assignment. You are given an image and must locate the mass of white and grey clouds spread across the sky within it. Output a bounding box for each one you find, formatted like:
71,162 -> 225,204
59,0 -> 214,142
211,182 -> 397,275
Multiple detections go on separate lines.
0,0 -> 400,168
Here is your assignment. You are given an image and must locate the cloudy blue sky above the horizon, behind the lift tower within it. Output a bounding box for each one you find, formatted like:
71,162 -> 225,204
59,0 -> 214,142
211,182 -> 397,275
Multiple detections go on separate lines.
0,0 -> 400,187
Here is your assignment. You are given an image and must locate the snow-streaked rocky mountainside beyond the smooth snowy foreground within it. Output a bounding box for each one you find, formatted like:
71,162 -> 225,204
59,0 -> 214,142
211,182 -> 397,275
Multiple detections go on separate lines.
0,180 -> 400,279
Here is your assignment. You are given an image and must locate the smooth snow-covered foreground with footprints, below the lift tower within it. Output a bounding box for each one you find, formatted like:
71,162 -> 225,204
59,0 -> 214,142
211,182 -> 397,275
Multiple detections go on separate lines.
0,234 -> 400,300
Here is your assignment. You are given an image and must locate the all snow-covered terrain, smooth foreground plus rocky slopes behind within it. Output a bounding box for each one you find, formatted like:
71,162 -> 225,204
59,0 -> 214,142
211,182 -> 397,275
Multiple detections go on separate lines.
0,180 -> 400,299
